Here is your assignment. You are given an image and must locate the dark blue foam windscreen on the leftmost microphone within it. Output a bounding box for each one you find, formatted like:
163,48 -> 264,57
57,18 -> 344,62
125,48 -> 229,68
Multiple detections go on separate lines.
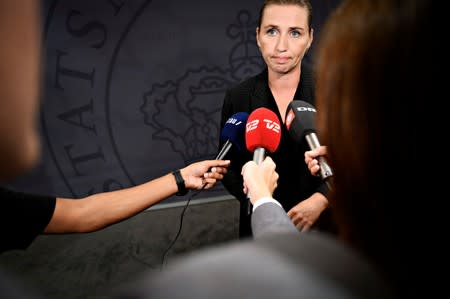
220,112 -> 248,151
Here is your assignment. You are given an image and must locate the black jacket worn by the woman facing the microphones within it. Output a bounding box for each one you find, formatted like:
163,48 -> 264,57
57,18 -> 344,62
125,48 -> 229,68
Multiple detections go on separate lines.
219,64 -> 331,236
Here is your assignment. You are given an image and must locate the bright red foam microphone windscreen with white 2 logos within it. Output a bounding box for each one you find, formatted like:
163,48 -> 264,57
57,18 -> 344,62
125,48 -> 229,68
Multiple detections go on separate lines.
245,107 -> 281,153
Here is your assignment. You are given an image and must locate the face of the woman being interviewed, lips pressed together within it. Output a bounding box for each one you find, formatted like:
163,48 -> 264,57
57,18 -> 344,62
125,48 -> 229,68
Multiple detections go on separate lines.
256,5 -> 313,74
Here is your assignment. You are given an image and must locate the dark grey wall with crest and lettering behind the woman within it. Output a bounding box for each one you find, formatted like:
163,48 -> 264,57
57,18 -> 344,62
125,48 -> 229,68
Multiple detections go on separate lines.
0,0 -> 338,298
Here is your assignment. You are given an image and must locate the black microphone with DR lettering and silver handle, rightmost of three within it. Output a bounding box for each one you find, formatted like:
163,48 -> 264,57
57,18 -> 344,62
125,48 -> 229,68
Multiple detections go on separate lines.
286,100 -> 333,185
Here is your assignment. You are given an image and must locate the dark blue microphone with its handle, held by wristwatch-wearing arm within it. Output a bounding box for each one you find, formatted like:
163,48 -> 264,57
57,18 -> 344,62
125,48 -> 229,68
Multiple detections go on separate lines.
216,112 -> 248,160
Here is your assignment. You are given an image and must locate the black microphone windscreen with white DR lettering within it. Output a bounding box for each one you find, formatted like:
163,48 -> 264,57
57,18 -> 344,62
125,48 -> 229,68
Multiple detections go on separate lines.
285,100 -> 316,142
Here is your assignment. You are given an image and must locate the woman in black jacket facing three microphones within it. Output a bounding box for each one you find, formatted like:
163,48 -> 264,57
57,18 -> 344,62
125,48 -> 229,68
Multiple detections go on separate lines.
220,0 -> 332,237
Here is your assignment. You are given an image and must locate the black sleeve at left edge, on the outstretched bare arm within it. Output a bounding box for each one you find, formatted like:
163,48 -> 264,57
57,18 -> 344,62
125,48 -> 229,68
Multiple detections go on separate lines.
0,188 -> 56,253
